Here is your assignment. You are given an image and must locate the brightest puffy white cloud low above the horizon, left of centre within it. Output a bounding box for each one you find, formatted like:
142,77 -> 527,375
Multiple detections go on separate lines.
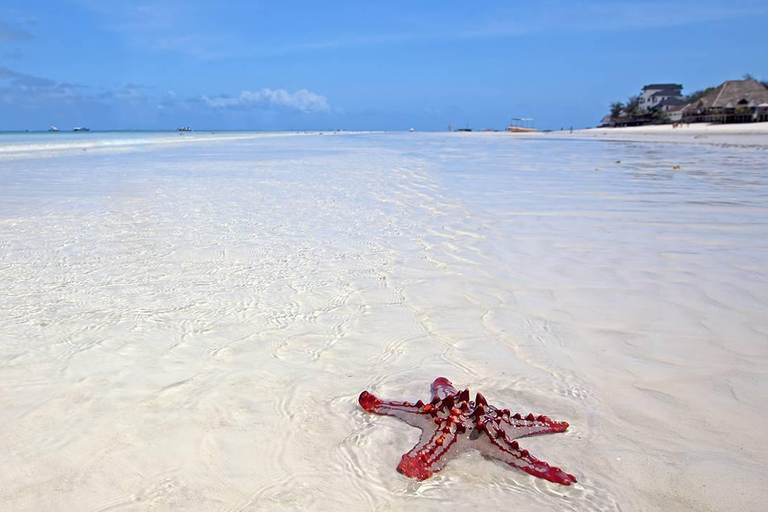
199,88 -> 330,112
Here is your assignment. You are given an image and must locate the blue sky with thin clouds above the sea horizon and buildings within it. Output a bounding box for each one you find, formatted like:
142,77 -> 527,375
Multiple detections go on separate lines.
0,0 -> 768,130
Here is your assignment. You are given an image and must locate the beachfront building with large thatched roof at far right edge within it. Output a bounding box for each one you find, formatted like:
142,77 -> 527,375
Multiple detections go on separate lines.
683,80 -> 768,123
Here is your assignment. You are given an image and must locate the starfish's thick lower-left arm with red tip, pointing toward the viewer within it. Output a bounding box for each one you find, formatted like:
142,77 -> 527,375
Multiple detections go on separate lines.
397,425 -> 458,480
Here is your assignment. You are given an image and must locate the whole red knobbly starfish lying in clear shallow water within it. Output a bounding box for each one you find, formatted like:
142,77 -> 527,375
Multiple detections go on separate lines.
359,377 -> 576,485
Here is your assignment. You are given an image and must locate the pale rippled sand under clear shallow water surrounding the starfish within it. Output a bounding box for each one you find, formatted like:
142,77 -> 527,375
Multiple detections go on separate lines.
0,133 -> 768,511
